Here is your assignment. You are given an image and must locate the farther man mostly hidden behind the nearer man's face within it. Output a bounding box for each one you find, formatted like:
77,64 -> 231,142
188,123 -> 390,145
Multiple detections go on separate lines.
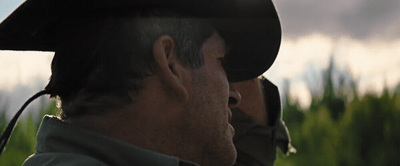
230,77 -> 296,166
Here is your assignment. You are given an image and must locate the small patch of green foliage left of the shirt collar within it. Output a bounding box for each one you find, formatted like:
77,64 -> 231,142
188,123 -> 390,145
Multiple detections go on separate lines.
0,102 -> 57,166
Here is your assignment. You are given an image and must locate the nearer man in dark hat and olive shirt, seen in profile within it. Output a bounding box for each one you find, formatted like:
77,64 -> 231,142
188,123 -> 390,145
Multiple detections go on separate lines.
0,0 -> 280,166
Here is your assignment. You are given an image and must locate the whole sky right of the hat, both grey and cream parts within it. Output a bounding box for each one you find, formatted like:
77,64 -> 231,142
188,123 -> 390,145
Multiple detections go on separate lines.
265,0 -> 400,106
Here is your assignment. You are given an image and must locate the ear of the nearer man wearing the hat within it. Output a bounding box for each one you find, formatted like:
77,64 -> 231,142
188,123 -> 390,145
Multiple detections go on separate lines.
153,35 -> 189,102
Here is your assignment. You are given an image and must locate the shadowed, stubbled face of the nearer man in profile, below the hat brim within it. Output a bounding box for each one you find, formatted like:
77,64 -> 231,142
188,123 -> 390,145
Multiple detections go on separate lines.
184,33 -> 236,166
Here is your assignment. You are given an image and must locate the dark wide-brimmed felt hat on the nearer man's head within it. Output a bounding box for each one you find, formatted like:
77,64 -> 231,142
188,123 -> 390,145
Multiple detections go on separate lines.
0,0 -> 281,81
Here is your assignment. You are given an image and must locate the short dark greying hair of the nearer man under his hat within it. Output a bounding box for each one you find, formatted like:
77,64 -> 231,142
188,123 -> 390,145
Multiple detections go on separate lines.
46,13 -> 214,119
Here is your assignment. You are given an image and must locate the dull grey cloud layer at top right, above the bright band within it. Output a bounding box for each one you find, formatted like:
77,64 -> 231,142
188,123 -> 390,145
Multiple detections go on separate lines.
274,0 -> 400,40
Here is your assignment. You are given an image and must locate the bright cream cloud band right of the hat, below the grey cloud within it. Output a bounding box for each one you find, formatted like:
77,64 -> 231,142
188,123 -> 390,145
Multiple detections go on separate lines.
264,34 -> 400,100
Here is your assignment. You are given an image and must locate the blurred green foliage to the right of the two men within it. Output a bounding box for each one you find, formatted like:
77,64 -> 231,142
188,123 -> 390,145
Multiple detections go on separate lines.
275,57 -> 400,166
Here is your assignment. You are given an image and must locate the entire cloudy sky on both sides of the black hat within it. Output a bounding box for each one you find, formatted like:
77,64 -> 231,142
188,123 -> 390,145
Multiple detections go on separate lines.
0,0 -> 400,115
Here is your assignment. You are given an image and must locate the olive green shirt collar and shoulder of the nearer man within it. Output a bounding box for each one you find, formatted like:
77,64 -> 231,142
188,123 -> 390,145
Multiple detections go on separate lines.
24,116 -> 194,166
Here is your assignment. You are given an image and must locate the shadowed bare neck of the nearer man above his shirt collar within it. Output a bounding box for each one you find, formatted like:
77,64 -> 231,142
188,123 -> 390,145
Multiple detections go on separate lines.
65,80 -> 188,156
